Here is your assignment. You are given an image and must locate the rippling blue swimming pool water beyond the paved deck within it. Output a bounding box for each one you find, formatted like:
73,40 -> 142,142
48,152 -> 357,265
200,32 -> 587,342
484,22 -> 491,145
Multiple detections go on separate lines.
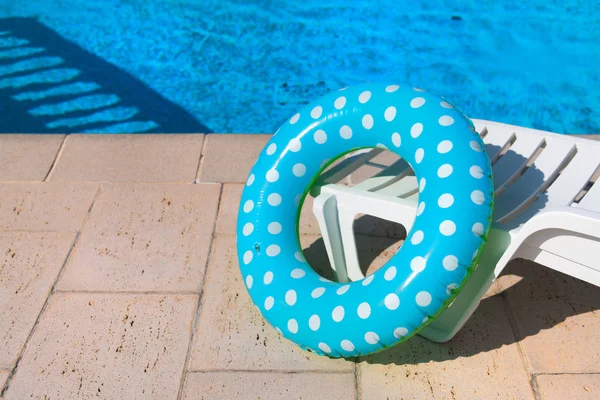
0,0 -> 600,133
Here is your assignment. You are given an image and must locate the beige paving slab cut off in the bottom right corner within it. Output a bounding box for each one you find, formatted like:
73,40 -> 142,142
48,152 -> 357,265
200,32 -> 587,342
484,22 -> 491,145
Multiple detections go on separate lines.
535,374 -> 600,400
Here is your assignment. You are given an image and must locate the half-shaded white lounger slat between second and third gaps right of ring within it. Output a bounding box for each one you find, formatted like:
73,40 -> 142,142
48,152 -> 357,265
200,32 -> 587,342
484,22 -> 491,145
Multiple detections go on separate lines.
494,139 -> 575,223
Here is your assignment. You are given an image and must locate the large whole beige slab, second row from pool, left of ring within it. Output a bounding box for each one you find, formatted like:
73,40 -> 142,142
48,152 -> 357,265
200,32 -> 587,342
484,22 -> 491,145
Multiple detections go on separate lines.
58,183 -> 220,291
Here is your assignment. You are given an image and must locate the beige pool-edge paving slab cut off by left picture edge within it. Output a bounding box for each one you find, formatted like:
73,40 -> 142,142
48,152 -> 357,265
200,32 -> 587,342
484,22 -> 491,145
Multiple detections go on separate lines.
0,135 -> 65,181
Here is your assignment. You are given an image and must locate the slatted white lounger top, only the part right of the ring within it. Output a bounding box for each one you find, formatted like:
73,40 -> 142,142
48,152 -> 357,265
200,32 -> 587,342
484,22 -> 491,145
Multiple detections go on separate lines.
473,120 -> 600,229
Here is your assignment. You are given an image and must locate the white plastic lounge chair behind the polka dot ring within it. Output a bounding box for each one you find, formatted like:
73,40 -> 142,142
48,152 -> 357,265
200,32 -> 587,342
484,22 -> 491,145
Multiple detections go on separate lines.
312,120 -> 600,342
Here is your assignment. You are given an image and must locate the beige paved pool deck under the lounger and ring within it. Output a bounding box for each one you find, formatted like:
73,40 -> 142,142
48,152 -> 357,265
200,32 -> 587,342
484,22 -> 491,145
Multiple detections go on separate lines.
0,134 -> 600,400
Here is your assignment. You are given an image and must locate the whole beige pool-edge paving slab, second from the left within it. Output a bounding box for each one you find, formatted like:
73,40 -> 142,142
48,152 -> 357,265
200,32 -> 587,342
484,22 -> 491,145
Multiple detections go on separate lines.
50,134 -> 204,182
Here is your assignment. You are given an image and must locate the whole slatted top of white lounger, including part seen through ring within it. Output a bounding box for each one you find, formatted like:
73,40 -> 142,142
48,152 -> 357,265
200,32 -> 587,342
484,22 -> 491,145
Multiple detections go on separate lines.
312,119 -> 600,230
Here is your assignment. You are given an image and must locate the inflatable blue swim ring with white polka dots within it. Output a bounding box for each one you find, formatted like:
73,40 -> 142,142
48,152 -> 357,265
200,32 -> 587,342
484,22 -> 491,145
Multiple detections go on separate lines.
237,84 -> 493,357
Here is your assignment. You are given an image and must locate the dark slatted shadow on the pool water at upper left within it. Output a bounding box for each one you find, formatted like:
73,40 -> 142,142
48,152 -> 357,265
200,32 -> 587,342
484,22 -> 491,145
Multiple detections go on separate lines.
0,18 -> 210,133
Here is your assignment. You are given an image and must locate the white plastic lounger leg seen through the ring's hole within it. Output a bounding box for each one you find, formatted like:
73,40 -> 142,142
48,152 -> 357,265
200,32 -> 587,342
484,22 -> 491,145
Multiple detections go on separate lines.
313,193 -> 348,282
